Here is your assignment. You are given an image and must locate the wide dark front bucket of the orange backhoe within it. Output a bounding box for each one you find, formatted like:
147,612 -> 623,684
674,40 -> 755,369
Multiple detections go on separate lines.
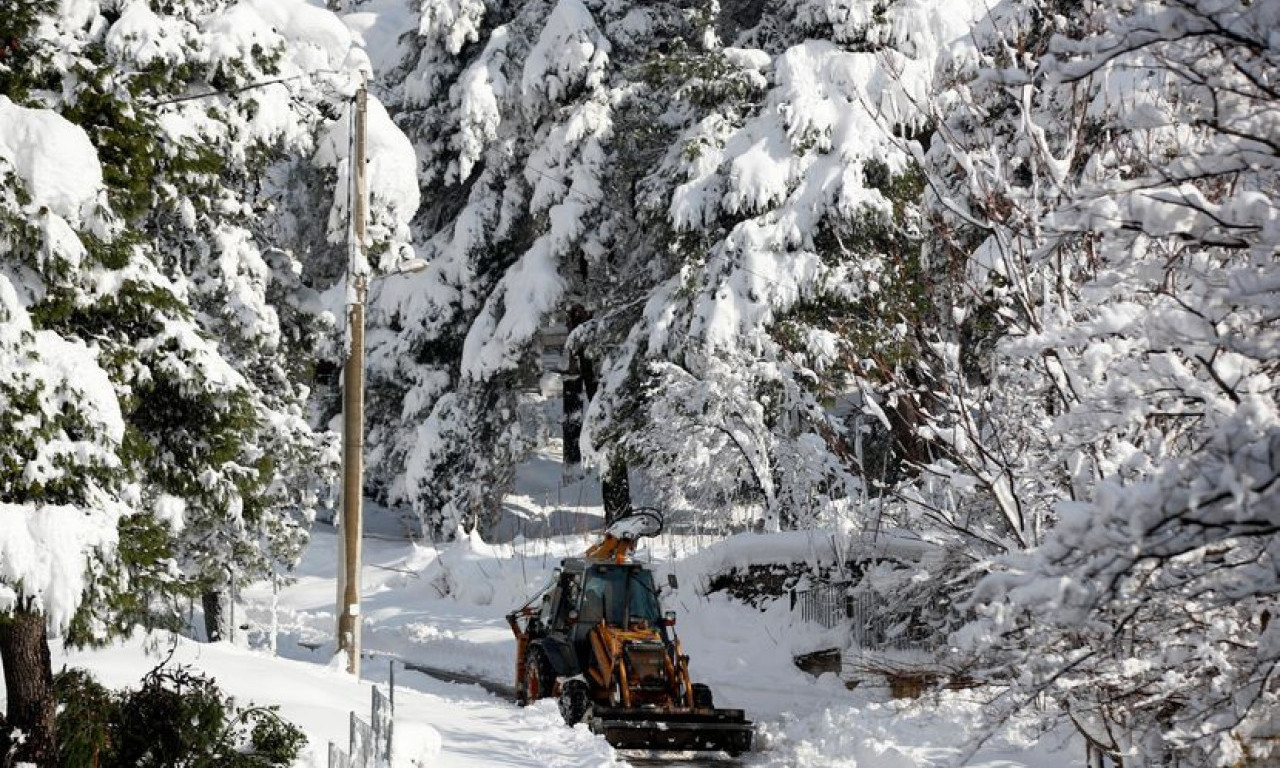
590,709 -> 751,755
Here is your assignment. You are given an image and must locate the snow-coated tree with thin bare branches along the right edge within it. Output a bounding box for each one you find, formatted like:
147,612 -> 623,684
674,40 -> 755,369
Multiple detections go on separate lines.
928,0 -> 1280,765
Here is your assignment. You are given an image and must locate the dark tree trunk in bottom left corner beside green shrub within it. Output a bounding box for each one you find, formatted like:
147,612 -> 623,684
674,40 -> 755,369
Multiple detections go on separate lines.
0,611 -> 58,768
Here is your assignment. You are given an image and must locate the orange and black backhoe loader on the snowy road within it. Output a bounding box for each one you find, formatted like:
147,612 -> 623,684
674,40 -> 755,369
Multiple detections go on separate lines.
507,509 -> 751,754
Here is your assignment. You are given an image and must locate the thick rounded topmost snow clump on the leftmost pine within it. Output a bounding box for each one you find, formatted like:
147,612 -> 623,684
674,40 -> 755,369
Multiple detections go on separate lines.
0,96 -> 102,223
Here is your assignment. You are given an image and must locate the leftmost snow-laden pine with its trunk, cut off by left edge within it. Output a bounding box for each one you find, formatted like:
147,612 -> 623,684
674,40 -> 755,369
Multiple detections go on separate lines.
0,96 -> 175,765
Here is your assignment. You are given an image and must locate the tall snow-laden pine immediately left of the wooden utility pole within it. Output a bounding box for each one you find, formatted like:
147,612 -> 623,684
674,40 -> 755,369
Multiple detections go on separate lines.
16,0 -> 416,634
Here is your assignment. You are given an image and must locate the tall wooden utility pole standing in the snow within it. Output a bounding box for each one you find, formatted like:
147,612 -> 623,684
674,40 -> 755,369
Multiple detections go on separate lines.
338,76 -> 369,677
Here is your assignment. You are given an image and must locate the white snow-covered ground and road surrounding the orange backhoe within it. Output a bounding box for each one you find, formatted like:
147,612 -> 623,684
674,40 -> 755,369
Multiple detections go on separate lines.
45,448 -> 1083,768
